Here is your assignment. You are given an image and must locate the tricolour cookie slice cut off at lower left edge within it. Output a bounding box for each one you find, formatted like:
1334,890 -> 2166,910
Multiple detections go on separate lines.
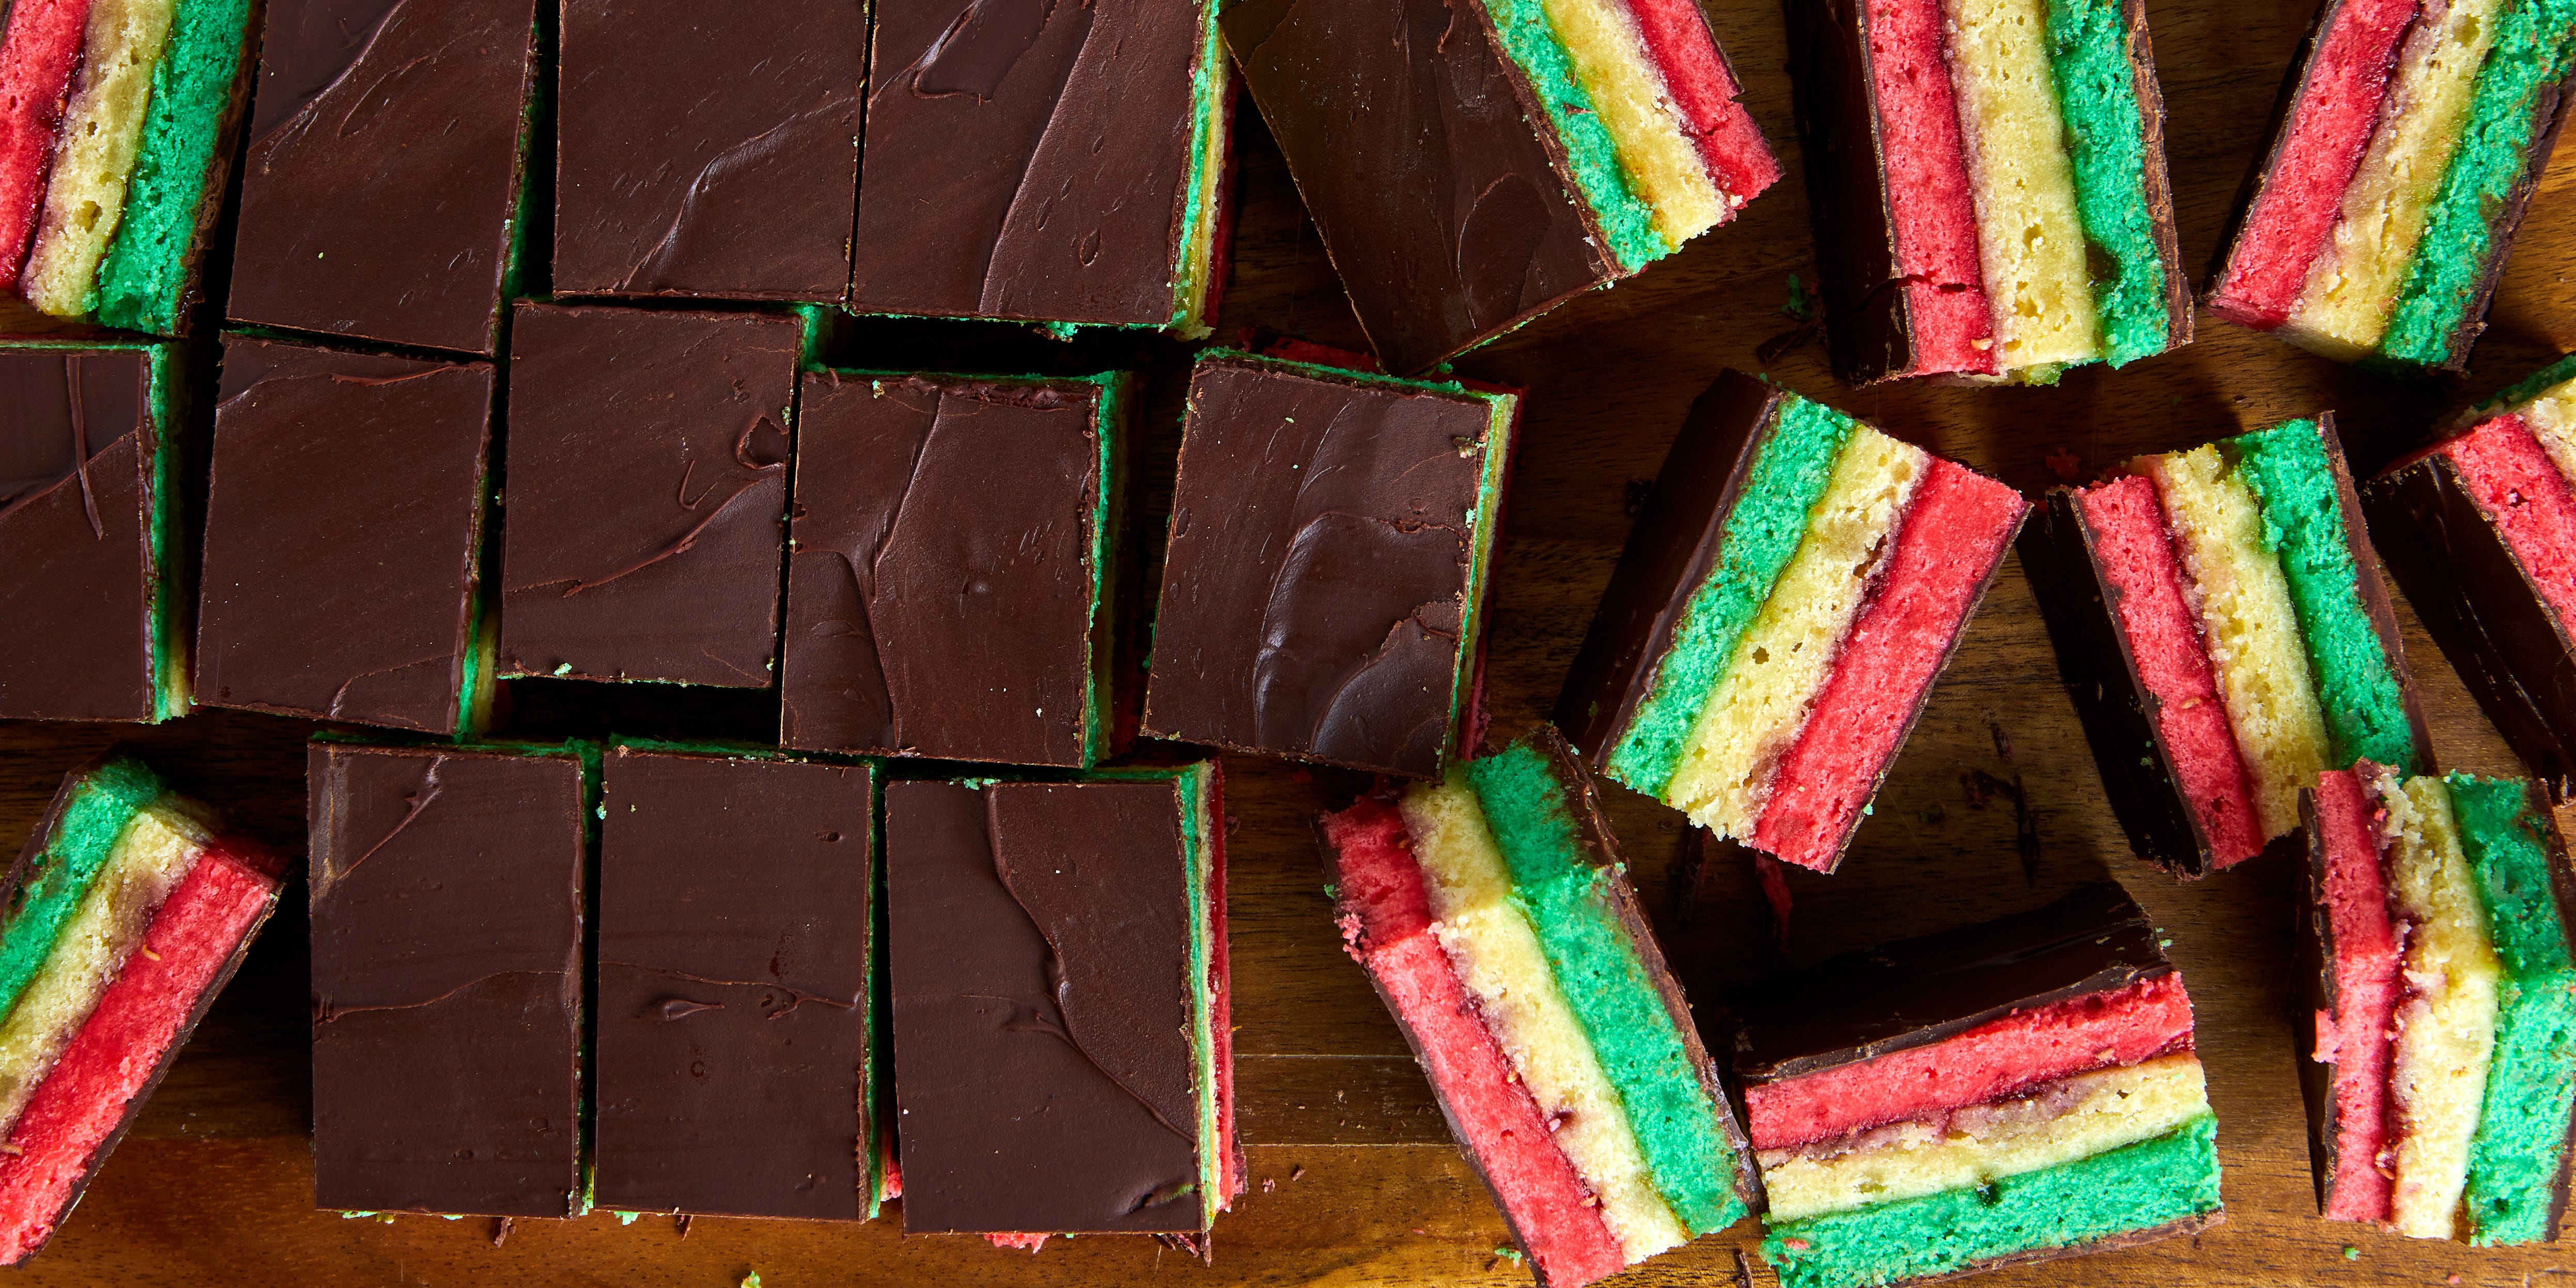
0,755 -> 281,1265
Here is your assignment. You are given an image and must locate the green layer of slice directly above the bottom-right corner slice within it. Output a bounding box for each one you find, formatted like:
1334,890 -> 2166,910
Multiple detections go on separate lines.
2231,420 -> 2416,773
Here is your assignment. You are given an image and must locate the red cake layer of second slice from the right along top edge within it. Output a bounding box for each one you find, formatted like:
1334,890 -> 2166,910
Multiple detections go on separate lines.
1870,0 -> 1994,376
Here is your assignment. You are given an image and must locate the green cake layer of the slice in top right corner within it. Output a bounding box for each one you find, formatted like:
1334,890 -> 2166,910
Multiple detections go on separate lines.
2380,0 -> 2576,366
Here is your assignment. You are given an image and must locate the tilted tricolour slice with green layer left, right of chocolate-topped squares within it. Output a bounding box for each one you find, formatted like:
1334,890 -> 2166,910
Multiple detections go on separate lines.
1556,371 -> 2027,871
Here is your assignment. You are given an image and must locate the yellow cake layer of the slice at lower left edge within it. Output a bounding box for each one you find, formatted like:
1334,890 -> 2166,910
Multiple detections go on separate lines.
0,806 -> 204,1136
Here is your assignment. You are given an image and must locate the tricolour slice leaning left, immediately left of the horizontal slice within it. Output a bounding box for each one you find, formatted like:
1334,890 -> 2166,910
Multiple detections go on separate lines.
1324,729 -> 1759,1288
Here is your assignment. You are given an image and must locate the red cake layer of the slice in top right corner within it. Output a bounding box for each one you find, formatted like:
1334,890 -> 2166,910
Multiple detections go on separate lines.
2210,0 -> 2419,330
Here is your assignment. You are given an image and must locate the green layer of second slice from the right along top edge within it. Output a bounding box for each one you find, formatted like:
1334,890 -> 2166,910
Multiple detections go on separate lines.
2048,0 -> 2171,366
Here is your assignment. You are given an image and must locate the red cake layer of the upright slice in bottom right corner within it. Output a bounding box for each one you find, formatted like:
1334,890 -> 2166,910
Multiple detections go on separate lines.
2316,770 -> 2398,1221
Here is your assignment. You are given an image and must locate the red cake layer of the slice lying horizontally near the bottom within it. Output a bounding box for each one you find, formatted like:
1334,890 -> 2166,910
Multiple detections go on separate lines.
1744,971 -> 2192,1149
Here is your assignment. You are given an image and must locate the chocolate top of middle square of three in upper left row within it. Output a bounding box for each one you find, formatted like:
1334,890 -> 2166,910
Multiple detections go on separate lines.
554,0 -> 865,301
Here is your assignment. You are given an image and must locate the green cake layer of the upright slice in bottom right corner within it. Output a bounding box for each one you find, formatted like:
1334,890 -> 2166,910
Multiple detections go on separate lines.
2445,773 -> 2576,1244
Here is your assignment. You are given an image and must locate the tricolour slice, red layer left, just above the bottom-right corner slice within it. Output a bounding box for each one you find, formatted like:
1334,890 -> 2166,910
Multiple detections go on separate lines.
2022,412 -> 2432,876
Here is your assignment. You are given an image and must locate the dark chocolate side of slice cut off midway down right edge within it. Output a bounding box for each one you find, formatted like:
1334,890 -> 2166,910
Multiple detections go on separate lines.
2365,451 -> 2576,801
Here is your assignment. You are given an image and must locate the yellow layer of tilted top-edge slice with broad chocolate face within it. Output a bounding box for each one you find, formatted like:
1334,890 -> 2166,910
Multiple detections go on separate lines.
1543,0 -> 1731,247
